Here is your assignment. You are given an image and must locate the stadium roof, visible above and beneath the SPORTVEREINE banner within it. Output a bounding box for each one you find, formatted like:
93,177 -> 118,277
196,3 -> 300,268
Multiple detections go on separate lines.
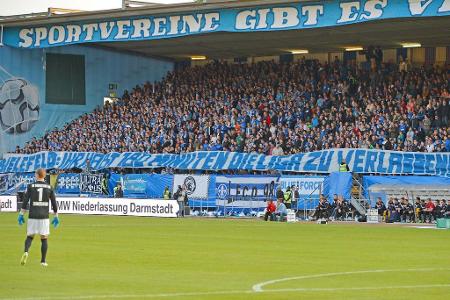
0,0 -> 450,60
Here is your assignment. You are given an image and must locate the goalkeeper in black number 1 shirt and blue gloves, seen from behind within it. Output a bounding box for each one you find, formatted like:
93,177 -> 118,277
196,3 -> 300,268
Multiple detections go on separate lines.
17,169 -> 59,267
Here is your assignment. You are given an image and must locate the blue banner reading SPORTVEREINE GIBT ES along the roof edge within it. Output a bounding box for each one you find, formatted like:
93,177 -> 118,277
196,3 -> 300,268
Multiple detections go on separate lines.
3,0 -> 450,48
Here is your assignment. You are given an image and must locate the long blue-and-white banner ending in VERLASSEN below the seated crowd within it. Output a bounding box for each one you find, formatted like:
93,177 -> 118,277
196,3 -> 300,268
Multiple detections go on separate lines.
0,149 -> 450,176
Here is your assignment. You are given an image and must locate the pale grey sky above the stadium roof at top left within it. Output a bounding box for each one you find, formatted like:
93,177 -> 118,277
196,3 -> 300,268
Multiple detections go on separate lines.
0,0 -> 192,16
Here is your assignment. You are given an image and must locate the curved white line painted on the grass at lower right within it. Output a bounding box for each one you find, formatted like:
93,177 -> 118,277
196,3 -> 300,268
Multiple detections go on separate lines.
252,268 -> 450,292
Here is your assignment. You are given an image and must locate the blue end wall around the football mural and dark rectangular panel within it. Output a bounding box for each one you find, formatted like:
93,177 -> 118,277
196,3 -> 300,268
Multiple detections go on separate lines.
0,46 -> 174,155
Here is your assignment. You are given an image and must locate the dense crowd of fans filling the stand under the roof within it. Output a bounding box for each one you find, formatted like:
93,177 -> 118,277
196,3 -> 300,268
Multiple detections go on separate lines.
16,58 -> 450,155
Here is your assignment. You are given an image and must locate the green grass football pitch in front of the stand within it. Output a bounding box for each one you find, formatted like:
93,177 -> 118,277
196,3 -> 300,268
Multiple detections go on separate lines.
0,213 -> 450,300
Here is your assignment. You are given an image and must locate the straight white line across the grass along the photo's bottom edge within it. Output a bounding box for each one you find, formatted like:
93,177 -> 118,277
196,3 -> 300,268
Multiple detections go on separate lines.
0,284 -> 450,300
